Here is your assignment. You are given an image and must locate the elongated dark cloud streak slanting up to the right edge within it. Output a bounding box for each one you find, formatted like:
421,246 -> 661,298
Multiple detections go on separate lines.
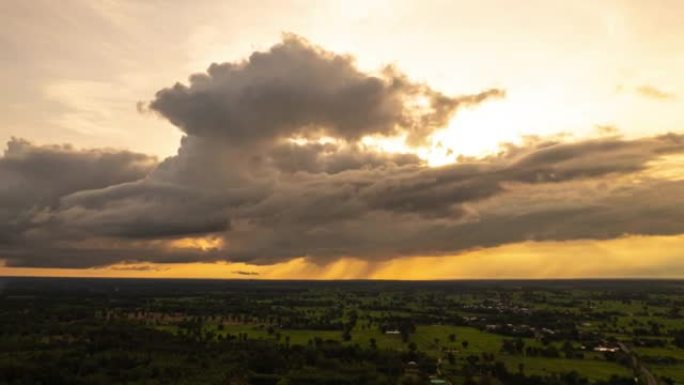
359,135 -> 684,215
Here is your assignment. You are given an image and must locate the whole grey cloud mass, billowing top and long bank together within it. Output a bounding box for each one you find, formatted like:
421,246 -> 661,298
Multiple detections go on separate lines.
0,36 -> 684,268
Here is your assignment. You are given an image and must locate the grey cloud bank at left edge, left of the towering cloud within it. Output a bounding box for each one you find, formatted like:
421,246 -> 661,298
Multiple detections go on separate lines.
0,139 -> 157,244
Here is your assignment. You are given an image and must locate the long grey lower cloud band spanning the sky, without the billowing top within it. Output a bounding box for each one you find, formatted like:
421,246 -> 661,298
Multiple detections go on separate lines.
5,135 -> 684,267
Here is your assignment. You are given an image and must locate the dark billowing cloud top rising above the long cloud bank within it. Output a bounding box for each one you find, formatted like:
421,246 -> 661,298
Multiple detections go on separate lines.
150,36 -> 504,146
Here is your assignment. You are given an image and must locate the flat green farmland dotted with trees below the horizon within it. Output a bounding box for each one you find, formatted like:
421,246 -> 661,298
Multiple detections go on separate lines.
0,278 -> 684,385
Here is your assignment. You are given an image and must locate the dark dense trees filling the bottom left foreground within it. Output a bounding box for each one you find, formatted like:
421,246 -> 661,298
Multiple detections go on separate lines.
0,321 -> 428,385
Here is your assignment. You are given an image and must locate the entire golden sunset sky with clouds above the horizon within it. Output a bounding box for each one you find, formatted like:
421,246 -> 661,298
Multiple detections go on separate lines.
0,0 -> 684,279
